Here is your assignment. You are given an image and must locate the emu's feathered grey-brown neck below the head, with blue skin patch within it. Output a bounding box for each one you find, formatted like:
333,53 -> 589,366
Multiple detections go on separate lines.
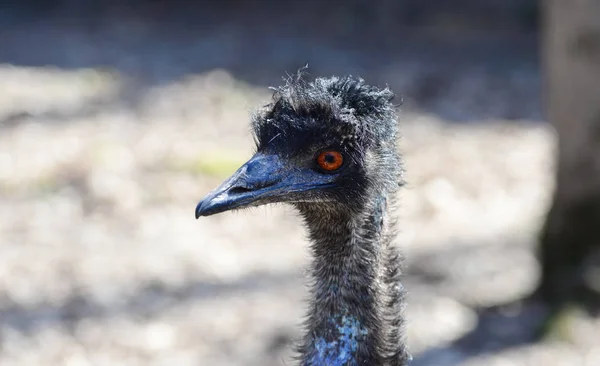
300,196 -> 401,366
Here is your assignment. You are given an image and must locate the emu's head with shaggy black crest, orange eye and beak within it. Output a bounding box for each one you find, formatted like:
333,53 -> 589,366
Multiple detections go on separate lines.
196,74 -> 400,218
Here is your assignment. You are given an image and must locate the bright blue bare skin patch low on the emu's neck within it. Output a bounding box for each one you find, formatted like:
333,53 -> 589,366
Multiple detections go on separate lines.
308,315 -> 367,366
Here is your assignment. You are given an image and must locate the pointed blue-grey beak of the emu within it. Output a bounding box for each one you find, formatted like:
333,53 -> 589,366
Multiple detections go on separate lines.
196,153 -> 290,218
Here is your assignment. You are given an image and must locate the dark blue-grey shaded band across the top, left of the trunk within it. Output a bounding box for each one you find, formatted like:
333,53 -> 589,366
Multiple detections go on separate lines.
0,0 -> 541,122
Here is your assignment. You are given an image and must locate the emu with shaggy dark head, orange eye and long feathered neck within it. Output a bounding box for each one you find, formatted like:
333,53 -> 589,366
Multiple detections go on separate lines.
196,72 -> 411,366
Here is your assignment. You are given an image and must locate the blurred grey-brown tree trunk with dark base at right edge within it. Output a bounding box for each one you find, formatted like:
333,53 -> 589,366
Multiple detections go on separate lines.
537,0 -> 600,306
